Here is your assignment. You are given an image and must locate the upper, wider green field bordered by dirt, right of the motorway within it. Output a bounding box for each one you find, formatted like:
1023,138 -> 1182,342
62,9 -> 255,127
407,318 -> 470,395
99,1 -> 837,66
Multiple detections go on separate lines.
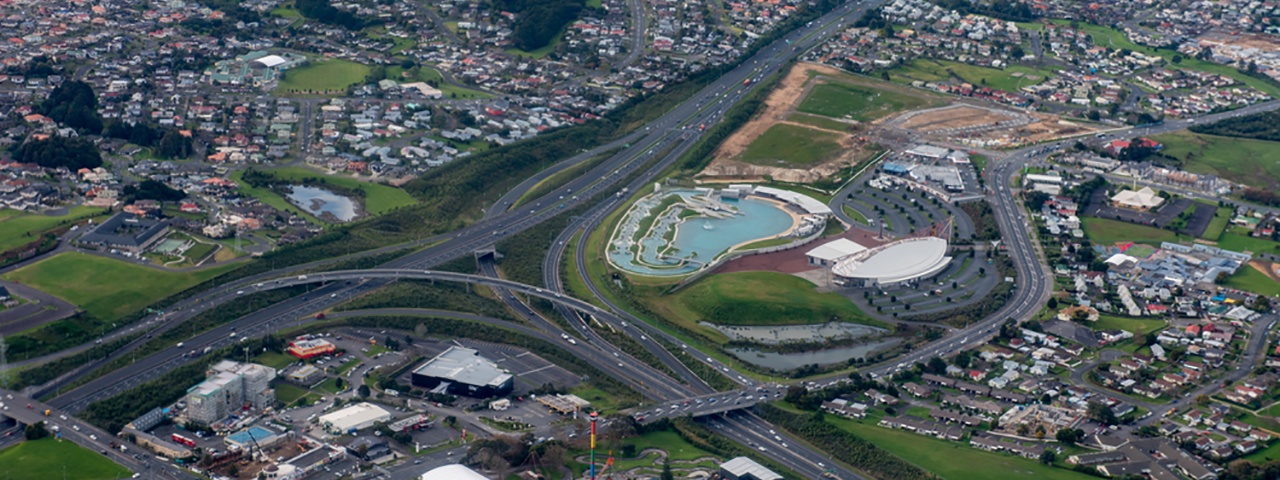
797,83 -> 928,122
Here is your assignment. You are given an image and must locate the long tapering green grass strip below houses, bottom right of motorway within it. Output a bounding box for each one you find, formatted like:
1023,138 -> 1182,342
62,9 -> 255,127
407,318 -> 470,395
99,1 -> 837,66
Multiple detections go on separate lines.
826,415 -> 1092,480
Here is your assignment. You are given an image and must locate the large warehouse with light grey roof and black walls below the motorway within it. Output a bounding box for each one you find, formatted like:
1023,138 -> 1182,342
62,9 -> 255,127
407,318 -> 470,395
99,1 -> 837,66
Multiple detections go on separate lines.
412,347 -> 515,398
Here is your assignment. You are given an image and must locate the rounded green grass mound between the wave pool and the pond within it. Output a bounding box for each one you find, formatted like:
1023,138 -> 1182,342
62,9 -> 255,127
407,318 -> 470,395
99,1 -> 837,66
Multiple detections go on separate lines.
669,271 -> 879,325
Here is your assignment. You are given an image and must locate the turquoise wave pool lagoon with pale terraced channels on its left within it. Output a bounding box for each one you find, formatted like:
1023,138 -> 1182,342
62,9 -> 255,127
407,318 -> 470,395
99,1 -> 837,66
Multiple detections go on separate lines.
609,189 -> 795,275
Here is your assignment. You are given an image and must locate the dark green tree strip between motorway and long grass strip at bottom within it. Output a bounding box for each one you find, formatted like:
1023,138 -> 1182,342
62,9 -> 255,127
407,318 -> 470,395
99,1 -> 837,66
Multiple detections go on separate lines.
756,404 -> 936,480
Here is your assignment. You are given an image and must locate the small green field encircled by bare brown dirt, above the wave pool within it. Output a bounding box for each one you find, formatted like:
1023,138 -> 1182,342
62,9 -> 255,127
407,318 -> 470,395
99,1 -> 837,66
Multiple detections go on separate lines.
742,123 -> 841,166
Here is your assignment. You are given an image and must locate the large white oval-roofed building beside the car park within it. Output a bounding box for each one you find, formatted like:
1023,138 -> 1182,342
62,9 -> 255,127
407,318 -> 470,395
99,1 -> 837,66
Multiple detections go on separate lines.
831,237 -> 951,287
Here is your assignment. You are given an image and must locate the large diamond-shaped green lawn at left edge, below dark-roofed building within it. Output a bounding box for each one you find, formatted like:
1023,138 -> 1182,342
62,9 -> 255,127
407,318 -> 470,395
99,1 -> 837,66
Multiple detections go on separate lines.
4,252 -> 239,320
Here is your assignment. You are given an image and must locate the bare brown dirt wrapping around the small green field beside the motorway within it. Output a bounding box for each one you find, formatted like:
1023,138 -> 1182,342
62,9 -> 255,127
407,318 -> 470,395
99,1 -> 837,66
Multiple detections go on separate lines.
699,63 -> 922,183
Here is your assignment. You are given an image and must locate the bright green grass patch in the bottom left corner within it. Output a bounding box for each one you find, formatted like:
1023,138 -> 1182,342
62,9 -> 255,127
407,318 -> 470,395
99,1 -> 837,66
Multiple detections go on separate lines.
0,438 -> 131,480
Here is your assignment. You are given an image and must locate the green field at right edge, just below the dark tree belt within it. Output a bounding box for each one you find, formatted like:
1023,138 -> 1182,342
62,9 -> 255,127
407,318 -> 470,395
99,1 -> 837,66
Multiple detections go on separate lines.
1153,131 -> 1280,189
